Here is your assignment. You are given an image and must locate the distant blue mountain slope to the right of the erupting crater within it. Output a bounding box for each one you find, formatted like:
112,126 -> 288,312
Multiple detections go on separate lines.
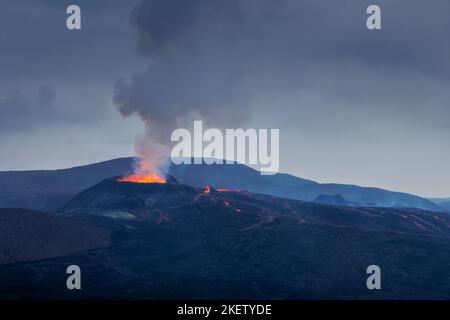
170,164 -> 444,211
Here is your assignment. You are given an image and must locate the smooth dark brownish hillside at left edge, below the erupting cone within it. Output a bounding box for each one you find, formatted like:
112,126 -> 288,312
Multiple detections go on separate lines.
0,209 -> 110,264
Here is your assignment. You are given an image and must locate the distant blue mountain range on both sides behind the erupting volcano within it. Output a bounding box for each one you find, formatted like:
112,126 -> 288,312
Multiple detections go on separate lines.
0,158 -> 444,211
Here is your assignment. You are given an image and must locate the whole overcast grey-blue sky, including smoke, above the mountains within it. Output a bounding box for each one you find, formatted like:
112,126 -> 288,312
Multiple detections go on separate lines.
0,0 -> 450,196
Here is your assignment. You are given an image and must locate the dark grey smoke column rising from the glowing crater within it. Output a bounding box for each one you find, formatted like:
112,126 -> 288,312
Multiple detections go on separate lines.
113,0 -> 250,172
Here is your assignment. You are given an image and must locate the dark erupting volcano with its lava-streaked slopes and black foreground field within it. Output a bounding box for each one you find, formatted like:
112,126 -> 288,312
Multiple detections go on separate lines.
0,177 -> 450,299
